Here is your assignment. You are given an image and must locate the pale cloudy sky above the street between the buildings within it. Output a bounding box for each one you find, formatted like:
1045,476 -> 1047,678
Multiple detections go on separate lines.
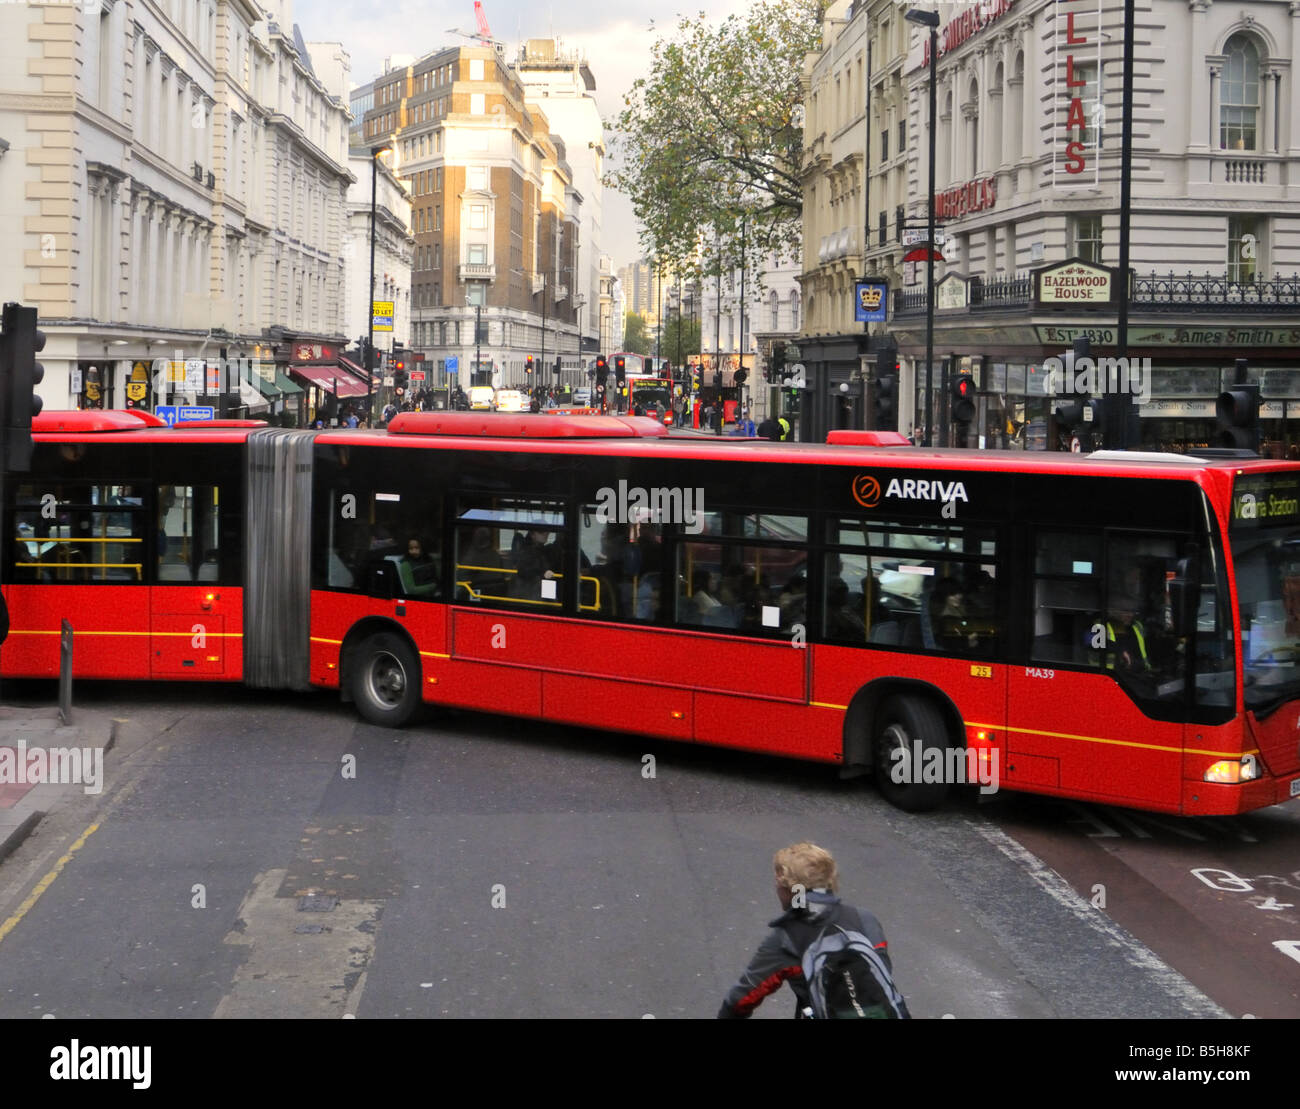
292,0 -> 746,272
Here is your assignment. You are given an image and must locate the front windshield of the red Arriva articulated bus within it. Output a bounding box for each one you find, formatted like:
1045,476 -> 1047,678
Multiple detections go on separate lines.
1231,473 -> 1300,711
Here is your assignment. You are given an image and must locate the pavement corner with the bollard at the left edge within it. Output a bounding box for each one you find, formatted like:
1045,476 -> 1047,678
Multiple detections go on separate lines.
0,705 -> 118,861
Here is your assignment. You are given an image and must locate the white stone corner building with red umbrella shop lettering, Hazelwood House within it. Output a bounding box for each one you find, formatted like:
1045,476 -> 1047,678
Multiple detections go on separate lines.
893,0 -> 1300,450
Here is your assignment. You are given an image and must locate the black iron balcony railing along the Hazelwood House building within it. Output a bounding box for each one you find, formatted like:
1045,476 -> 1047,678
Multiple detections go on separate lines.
894,270 -> 1300,316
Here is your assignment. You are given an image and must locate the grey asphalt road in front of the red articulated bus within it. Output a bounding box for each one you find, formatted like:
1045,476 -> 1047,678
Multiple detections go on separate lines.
0,684 -> 1300,1019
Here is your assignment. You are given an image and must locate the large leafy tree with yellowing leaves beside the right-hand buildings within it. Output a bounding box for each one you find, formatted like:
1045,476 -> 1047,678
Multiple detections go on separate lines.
607,0 -> 828,283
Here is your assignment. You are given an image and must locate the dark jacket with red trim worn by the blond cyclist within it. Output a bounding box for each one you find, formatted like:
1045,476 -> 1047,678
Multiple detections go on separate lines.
718,889 -> 893,1019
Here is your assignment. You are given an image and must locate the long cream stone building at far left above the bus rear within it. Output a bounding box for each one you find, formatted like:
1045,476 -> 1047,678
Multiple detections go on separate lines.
0,0 -> 347,421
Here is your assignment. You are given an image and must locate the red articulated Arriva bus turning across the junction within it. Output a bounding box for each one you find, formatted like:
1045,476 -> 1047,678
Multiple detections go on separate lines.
0,412 -> 1300,815
